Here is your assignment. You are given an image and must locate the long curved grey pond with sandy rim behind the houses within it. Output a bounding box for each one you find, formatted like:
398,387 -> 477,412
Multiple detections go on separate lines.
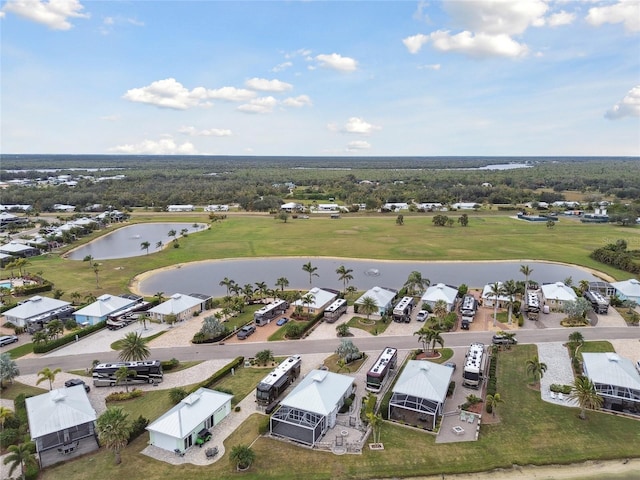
132,257 -> 601,297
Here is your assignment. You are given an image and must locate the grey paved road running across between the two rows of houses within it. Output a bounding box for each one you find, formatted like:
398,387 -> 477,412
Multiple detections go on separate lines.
17,327 -> 640,375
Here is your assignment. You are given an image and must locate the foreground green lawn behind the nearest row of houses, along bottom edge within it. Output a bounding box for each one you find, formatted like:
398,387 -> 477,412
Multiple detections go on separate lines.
41,345 -> 639,480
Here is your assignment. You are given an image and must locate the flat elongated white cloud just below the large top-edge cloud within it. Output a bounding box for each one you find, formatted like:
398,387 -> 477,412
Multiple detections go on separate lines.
430,30 -> 529,58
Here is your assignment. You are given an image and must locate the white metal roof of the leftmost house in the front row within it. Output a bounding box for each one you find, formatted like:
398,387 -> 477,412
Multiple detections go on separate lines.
26,385 -> 96,438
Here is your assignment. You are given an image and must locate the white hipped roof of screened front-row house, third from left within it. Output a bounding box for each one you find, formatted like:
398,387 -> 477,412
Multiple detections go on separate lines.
281,370 -> 354,415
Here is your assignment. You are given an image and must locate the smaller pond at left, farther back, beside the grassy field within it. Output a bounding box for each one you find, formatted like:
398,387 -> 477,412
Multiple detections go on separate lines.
67,223 -> 207,260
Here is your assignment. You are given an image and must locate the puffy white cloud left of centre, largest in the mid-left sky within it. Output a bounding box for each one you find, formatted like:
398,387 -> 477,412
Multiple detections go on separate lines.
123,78 -> 207,110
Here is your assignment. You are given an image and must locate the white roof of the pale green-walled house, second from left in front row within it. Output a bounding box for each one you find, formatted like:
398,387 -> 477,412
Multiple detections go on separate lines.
147,388 -> 233,438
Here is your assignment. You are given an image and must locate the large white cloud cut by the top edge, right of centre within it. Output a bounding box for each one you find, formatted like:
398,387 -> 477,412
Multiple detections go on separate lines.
443,0 -> 549,35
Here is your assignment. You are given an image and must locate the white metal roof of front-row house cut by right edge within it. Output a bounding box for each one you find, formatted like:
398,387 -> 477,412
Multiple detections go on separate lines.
582,352 -> 640,391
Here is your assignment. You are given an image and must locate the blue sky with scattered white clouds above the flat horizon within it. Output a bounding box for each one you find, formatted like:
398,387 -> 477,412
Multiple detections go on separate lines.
0,0 -> 640,156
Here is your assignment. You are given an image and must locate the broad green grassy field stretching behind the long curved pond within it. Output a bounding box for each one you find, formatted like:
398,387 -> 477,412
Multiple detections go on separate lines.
2,212 -> 640,300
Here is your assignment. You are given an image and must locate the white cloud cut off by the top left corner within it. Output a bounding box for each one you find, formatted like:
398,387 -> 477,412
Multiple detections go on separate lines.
2,0 -> 90,30
